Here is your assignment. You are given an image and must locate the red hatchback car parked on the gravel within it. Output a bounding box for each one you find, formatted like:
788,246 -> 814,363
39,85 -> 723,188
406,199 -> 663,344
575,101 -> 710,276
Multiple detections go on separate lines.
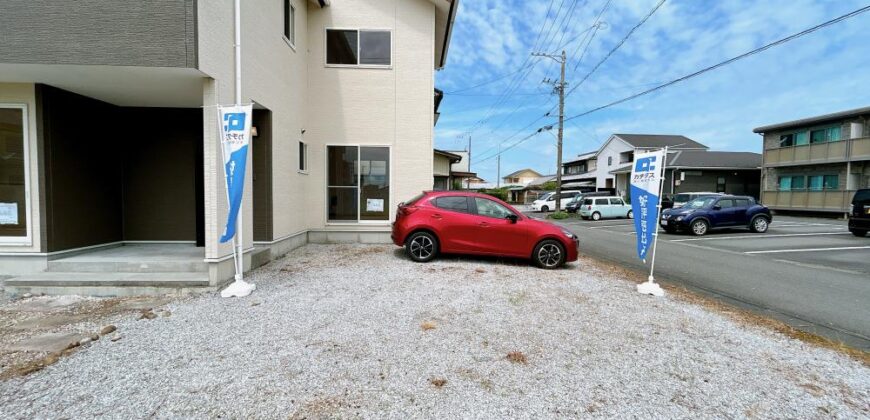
391,191 -> 579,269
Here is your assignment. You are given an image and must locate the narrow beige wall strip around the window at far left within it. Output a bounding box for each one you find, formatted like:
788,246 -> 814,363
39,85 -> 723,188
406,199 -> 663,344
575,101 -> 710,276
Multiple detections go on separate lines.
0,83 -> 42,253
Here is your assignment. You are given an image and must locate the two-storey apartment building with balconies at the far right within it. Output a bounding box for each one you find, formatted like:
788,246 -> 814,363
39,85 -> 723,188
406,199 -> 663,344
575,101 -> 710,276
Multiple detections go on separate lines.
752,107 -> 870,213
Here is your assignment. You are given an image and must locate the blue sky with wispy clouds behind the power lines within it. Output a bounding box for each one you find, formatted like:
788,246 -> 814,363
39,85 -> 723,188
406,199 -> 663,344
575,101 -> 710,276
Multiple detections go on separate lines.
435,0 -> 870,182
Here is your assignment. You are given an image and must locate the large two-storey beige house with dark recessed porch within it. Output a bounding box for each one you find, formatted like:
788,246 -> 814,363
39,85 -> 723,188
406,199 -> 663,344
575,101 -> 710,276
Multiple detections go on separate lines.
0,0 -> 458,293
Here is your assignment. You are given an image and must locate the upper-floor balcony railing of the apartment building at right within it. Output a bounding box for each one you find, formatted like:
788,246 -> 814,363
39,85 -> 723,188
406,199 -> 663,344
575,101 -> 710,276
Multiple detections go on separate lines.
764,137 -> 870,166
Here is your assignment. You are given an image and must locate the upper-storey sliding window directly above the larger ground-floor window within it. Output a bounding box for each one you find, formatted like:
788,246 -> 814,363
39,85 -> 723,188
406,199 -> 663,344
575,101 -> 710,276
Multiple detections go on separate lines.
326,29 -> 392,67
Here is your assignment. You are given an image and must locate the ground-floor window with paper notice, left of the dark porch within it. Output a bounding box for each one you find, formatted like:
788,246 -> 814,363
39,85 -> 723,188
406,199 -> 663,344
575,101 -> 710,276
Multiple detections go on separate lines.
0,105 -> 30,243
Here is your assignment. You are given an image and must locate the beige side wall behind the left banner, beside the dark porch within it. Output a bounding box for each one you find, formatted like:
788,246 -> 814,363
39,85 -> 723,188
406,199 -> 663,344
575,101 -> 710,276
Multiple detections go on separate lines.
198,0 -> 313,258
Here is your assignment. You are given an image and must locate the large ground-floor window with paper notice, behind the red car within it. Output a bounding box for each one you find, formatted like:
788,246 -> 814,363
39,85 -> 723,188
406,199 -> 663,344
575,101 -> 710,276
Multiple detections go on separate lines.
327,146 -> 390,222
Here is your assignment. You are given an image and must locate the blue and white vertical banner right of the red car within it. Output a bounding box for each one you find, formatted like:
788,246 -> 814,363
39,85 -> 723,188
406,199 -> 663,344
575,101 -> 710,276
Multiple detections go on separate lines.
629,150 -> 665,262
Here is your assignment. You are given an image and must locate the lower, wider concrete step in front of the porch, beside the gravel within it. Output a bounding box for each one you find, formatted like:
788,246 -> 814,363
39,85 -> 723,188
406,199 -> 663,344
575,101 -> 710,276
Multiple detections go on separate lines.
3,272 -> 213,296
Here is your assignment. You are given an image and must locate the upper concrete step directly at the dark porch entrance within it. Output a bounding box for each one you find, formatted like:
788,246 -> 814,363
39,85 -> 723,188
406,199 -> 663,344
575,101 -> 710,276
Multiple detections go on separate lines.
46,258 -> 208,273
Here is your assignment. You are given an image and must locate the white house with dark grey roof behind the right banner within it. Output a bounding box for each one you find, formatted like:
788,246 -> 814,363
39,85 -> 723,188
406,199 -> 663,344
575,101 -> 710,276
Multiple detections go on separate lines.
562,134 -> 708,192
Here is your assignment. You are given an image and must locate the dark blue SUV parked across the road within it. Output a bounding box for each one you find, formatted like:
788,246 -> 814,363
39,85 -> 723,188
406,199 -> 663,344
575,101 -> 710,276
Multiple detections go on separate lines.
659,195 -> 773,236
